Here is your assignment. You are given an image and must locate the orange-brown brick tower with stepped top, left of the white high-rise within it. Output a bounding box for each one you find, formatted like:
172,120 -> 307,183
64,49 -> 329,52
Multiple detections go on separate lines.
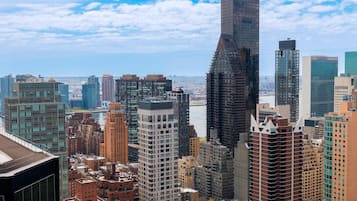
101,103 -> 128,164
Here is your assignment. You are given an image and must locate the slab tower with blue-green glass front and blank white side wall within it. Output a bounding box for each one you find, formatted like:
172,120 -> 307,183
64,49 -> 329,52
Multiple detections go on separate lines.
301,56 -> 338,118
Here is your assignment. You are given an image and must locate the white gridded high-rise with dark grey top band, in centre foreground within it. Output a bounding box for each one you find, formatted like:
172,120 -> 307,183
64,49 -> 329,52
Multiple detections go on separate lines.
138,99 -> 178,201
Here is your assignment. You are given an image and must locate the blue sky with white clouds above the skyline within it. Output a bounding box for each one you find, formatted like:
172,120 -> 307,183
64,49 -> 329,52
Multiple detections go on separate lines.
0,0 -> 357,76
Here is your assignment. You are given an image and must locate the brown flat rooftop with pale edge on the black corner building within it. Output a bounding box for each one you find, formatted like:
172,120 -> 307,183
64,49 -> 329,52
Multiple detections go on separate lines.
0,130 -> 55,176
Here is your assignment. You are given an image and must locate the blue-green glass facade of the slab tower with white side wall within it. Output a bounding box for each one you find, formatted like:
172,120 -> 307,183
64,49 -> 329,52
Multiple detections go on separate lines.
311,58 -> 338,117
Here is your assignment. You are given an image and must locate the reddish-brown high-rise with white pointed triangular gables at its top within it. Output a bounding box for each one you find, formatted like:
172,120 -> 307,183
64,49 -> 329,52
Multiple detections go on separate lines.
249,116 -> 303,201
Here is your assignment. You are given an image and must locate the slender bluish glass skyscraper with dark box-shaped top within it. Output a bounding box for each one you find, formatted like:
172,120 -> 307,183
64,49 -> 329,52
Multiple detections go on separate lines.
275,39 -> 300,122
